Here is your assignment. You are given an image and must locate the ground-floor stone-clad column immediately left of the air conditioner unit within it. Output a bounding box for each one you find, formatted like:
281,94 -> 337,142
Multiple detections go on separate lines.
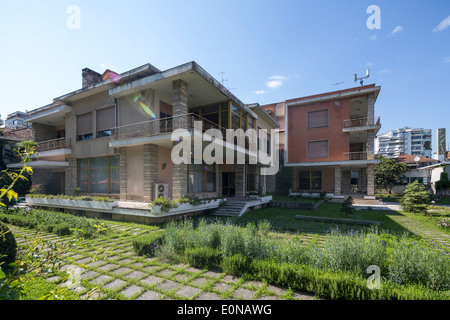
144,144 -> 158,202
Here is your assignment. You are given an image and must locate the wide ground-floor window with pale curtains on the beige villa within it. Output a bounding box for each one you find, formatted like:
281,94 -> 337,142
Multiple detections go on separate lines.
78,156 -> 120,194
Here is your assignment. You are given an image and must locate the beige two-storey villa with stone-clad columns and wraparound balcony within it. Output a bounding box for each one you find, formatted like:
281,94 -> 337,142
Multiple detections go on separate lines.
7,62 -> 279,216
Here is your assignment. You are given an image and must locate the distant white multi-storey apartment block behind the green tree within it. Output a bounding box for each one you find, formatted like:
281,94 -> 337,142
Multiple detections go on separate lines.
376,127 -> 431,158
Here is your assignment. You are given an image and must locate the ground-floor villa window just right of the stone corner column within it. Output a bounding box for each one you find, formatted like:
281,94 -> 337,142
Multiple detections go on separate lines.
188,164 -> 216,193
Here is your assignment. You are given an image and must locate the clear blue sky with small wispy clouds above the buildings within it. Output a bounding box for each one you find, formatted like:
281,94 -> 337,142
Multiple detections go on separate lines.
0,0 -> 450,152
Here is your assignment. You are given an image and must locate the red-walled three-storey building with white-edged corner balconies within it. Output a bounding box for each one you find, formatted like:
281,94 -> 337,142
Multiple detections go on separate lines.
263,85 -> 381,199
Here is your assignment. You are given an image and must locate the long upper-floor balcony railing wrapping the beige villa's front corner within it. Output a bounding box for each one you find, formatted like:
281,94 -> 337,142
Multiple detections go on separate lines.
111,113 -> 226,140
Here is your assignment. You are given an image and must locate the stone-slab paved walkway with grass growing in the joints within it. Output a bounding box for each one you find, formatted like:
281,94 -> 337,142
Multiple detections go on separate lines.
11,225 -> 320,300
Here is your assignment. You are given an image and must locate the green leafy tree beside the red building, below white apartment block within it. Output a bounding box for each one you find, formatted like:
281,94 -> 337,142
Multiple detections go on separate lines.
375,157 -> 408,194
